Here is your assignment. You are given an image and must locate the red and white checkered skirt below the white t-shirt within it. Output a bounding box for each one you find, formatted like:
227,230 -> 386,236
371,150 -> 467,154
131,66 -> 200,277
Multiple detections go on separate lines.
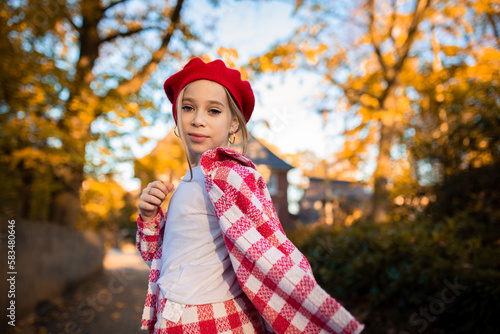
149,293 -> 266,334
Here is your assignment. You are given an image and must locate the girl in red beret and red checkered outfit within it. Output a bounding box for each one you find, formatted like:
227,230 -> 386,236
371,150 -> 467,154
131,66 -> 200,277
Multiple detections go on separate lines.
137,58 -> 363,334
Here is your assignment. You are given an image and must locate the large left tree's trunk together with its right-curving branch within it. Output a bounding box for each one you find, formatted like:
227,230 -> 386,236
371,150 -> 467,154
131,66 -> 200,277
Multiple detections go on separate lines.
46,0 -> 184,227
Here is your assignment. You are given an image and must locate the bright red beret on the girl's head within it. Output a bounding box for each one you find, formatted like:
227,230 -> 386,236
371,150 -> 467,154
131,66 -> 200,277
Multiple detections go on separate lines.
163,58 -> 255,124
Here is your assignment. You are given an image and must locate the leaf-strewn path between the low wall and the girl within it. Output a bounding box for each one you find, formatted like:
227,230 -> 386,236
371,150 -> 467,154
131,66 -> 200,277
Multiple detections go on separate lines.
10,245 -> 149,334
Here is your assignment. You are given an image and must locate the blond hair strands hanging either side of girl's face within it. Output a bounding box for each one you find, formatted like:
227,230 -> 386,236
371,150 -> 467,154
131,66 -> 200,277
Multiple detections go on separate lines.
176,84 -> 248,181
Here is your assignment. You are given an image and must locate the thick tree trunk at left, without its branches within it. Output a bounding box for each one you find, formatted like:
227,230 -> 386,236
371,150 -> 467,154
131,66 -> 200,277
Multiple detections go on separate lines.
49,0 -> 103,228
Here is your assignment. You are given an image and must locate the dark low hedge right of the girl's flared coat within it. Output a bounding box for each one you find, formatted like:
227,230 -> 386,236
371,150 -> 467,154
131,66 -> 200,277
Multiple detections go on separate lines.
290,214 -> 500,333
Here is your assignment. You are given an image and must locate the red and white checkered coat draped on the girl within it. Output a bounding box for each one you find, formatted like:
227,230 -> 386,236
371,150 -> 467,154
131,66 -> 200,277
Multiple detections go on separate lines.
137,147 -> 363,334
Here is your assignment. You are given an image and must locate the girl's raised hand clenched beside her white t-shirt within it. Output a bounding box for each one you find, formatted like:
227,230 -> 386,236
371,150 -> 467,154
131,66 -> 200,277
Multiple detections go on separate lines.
139,180 -> 174,222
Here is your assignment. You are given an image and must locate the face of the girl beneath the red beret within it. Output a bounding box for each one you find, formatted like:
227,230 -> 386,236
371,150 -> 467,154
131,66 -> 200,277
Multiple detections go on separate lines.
178,80 -> 238,166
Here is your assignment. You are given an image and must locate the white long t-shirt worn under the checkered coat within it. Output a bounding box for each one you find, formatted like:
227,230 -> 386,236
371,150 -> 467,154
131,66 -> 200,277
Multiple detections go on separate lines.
158,166 -> 242,305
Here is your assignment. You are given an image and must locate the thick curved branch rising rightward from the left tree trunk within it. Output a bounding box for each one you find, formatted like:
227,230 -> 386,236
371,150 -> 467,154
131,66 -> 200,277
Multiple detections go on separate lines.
106,0 -> 184,96
